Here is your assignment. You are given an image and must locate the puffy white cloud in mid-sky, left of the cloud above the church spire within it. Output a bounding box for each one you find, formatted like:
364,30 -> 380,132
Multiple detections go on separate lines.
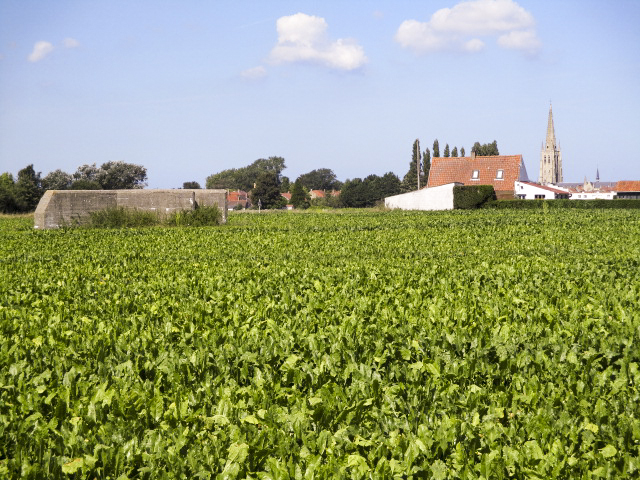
269,13 -> 367,70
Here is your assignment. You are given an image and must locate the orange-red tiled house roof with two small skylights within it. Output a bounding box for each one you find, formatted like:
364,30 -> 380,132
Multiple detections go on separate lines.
427,155 -> 529,191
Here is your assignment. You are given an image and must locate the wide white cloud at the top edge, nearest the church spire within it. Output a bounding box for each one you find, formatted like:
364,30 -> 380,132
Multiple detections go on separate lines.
395,0 -> 541,55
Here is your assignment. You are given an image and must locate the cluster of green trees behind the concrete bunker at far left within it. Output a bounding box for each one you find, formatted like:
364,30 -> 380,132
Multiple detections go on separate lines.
0,162 -> 147,213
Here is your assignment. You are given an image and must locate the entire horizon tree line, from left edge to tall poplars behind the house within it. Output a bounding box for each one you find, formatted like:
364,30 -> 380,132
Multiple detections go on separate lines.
0,139 -> 499,213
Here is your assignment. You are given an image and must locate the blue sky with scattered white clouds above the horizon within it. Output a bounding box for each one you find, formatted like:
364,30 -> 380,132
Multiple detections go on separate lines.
0,0 -> 640,188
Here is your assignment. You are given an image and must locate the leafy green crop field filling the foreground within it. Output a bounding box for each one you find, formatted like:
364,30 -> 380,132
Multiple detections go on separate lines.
0,209 -> 640,479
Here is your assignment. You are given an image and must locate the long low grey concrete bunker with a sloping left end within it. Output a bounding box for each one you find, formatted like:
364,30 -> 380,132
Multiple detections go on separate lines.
34,189 -> 227,229
